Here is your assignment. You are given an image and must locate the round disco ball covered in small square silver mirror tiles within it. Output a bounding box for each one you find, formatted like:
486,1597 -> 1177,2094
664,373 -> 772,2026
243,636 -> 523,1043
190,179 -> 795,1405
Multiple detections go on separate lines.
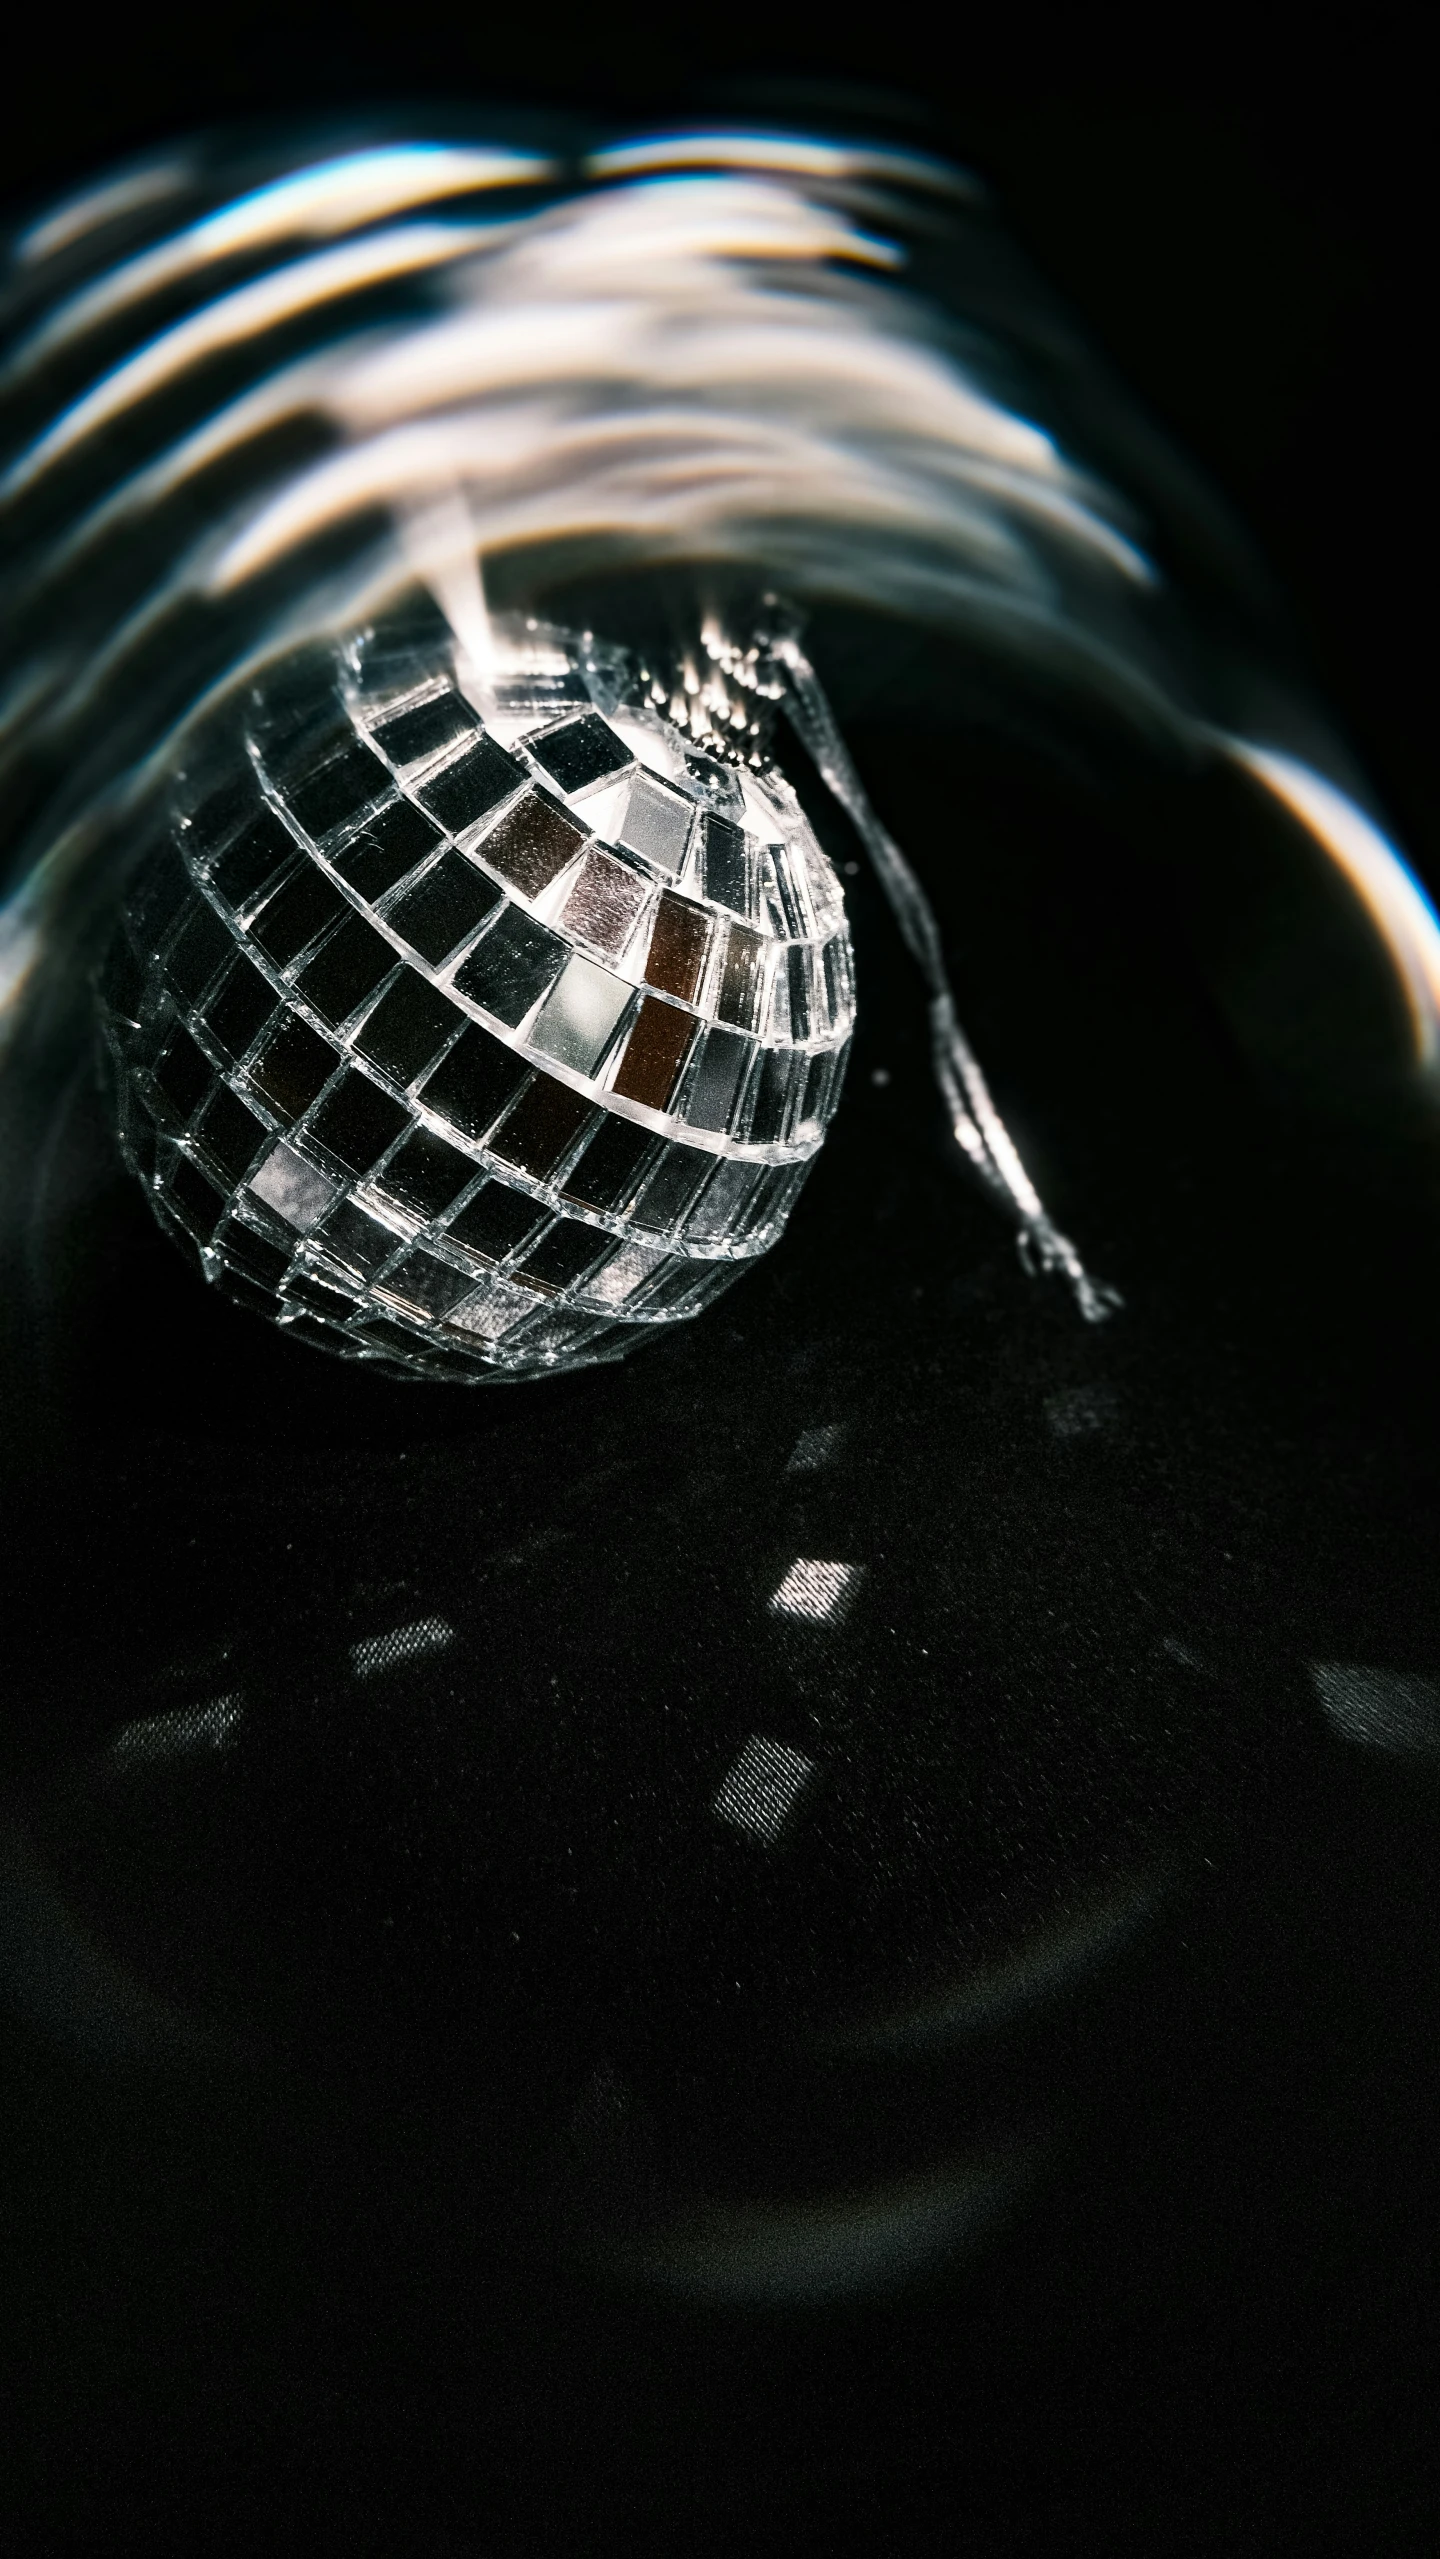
100,609 -> 854,1379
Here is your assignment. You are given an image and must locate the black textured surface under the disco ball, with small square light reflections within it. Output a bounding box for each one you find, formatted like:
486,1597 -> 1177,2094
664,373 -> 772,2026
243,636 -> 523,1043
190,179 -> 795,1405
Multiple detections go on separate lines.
0,55 -> 1440,2554
